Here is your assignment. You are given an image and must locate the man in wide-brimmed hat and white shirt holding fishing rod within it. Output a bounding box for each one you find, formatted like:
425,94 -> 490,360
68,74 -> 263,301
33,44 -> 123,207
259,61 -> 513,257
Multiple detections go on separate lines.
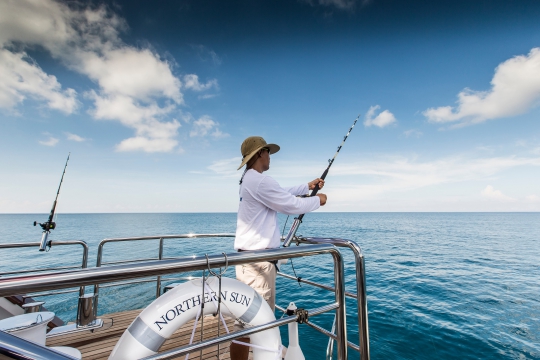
231,136 -> 326,360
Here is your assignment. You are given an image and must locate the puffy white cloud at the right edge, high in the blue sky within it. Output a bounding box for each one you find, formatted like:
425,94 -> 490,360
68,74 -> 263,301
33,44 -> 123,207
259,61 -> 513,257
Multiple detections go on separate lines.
423,48 -> 540,126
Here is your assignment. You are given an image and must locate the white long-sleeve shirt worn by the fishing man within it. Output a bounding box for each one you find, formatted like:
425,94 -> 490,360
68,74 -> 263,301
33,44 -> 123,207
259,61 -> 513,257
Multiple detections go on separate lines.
234,169 -> 320,250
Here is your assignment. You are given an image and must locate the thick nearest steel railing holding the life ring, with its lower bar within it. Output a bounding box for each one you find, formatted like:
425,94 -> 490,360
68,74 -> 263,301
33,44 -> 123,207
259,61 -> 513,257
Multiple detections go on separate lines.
0,244 -> 348,360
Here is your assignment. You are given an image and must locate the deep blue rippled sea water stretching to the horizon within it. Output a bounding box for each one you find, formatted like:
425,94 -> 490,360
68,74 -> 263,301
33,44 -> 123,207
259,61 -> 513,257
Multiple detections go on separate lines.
0,213 -> 540,360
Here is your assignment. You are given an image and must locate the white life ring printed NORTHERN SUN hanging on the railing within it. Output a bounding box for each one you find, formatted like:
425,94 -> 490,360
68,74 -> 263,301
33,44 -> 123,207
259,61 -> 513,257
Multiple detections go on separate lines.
109,277 -> 281,360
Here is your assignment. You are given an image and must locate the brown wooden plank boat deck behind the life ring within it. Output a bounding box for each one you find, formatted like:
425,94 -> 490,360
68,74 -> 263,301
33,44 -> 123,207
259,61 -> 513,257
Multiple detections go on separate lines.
47,310 -> 239,360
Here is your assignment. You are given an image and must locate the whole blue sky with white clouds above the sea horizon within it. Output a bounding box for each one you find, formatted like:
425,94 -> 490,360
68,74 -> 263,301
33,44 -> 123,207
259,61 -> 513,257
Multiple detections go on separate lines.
0,0 -> 540,213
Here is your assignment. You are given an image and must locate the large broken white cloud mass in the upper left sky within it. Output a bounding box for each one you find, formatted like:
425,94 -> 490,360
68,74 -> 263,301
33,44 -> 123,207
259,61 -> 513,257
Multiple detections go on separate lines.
0,0 -> 223,152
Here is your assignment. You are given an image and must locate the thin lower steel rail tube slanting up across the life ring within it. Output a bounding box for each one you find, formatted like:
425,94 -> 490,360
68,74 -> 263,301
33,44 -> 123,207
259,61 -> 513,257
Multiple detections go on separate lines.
143,304 -> 339,360
